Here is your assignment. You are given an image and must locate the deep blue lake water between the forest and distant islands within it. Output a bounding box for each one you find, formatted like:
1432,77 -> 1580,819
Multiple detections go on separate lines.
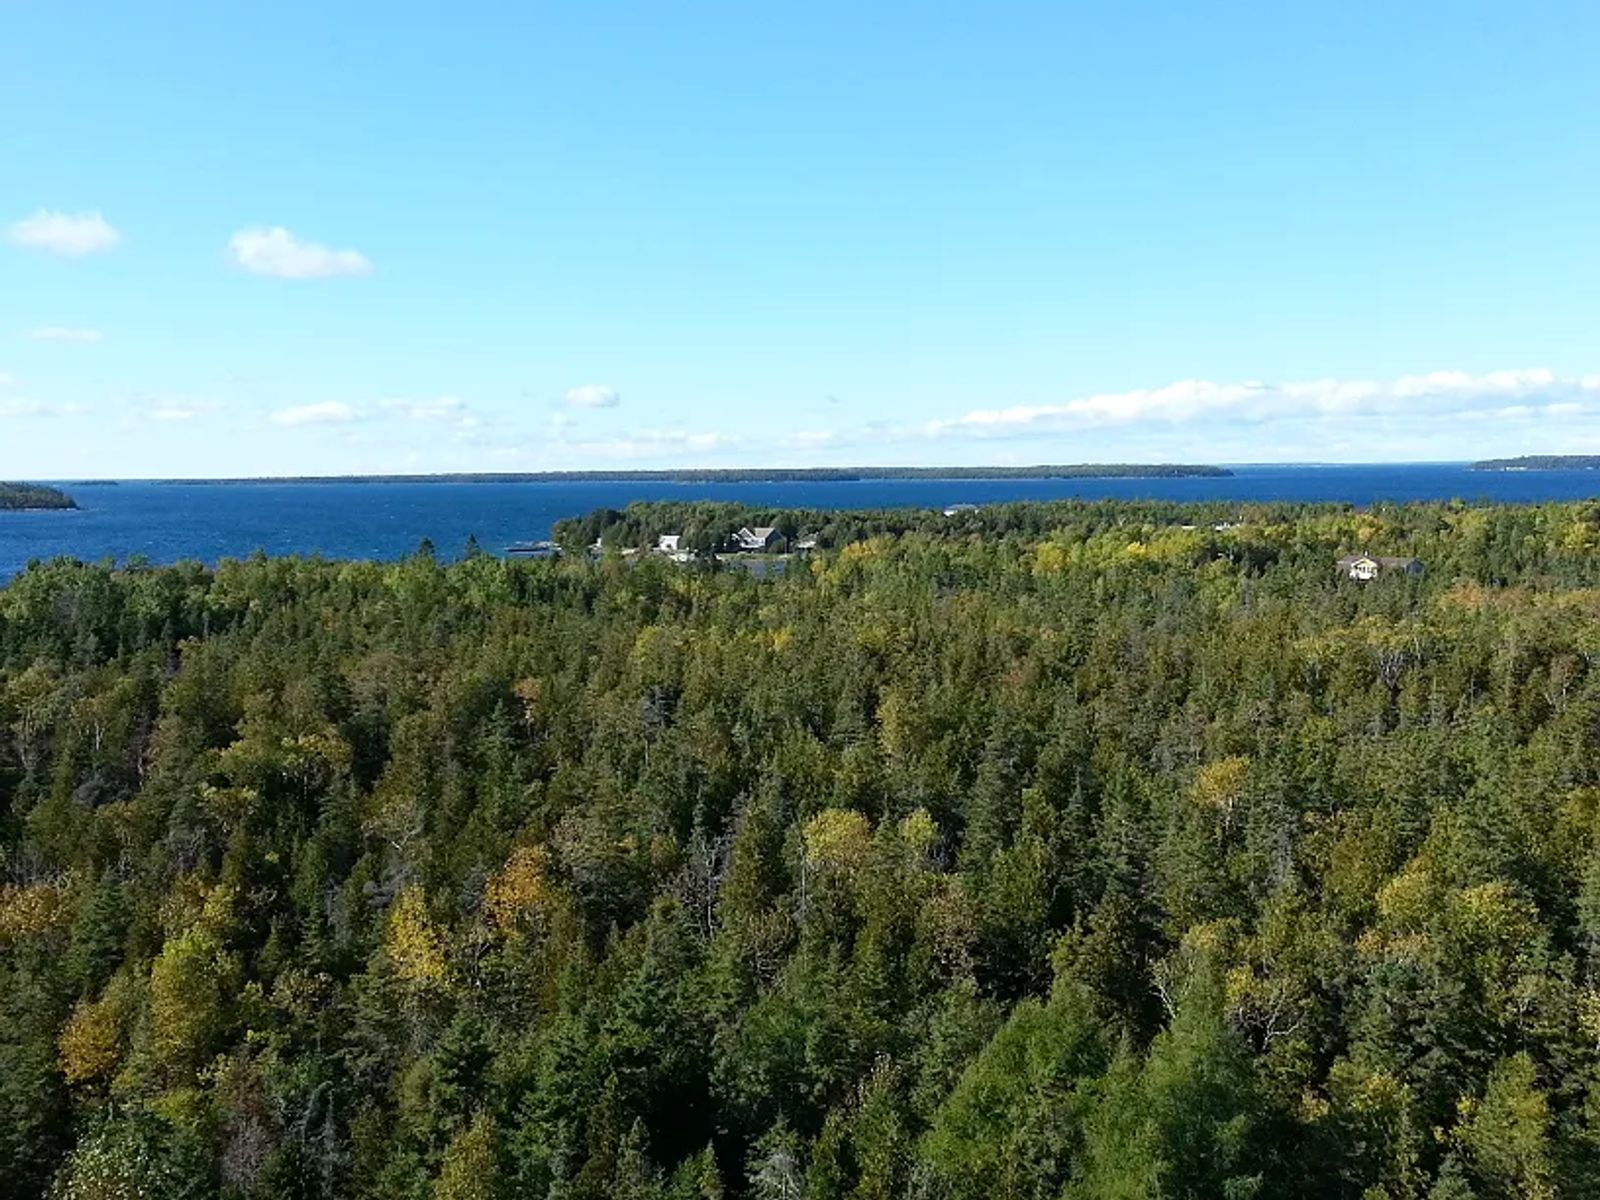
0,464 -> 1600,579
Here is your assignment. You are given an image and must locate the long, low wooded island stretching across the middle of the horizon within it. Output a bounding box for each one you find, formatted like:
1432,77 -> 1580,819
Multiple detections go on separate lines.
157,462 -> 1234,485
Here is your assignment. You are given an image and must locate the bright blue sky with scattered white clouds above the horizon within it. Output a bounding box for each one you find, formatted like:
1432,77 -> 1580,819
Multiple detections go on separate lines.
0,0 -> 1600,478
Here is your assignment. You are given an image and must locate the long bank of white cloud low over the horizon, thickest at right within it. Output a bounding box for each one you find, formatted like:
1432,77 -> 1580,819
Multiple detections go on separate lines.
482,368 -> 1600,467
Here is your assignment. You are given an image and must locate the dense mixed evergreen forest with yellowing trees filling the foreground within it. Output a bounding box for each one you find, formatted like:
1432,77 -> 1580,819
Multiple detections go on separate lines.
0,502 -> 1600,1200
